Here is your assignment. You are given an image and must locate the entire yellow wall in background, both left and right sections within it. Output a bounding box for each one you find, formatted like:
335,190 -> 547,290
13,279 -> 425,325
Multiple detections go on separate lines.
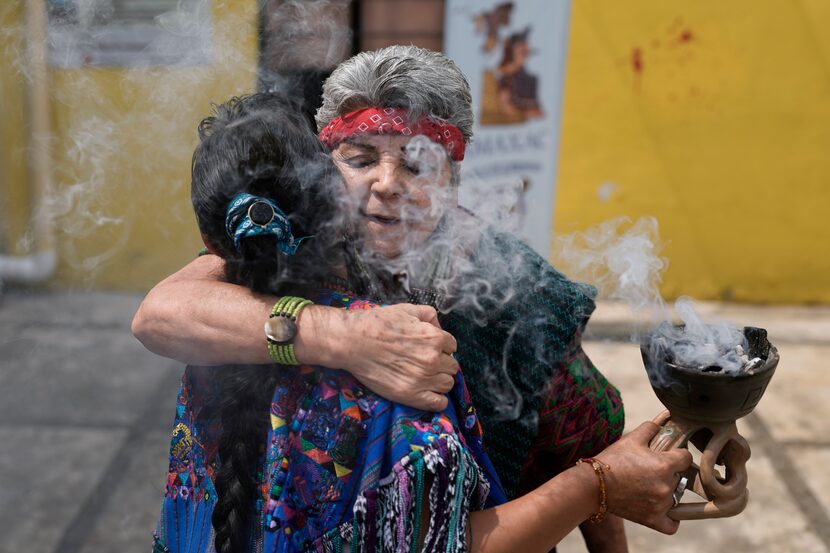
6,0 -> 830,302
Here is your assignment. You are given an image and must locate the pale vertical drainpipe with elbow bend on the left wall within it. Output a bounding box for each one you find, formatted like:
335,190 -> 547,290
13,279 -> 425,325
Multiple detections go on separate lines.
0,0 -> 57,282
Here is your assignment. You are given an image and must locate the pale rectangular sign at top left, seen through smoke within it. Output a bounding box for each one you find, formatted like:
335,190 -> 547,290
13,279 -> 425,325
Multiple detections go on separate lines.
46,0 -> 212,67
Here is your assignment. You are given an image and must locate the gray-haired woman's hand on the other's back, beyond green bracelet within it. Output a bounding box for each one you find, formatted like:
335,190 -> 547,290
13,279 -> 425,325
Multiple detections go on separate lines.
294,304 -> 458,411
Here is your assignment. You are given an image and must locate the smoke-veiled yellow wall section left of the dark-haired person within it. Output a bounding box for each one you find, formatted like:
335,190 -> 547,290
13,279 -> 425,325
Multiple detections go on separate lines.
0,0 -> 258,290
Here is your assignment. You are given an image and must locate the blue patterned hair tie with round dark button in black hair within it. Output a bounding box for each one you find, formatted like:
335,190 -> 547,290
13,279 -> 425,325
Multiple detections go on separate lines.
225,193 -> 312,255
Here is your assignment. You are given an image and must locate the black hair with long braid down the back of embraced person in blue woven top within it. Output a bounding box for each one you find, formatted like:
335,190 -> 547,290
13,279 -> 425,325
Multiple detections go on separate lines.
191,94 -> 340,553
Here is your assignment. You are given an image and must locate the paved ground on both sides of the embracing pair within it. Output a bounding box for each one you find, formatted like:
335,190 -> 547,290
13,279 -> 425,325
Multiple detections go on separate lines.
0,291 -> 830,553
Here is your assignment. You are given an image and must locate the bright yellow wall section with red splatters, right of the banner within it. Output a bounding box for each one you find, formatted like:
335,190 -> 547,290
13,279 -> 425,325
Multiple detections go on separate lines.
554,0 -> 830,302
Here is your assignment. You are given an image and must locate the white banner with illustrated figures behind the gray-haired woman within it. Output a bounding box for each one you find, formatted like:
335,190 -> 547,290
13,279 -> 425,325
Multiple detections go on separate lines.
444,0 -> 570,258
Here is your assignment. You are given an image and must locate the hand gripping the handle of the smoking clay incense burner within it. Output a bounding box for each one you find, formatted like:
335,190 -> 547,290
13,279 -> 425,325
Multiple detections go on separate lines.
597,422 -> 692,534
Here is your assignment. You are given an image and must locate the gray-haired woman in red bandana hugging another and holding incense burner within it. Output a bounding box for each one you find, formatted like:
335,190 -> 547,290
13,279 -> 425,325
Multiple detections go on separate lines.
138,46 -> 690,551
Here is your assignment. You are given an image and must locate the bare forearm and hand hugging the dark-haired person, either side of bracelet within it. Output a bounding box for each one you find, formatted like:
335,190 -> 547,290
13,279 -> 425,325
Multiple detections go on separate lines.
132,255 -> 458,411
